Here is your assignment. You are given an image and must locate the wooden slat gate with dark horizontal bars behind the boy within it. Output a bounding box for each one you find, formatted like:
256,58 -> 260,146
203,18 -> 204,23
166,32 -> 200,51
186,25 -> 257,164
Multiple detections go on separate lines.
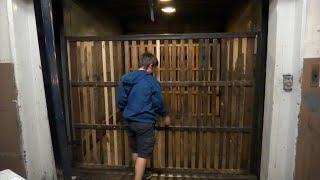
68,33 -> 258,179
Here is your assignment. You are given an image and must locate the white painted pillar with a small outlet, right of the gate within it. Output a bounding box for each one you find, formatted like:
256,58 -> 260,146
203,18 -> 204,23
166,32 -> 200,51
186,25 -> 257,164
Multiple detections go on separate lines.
261,0 -> 307,180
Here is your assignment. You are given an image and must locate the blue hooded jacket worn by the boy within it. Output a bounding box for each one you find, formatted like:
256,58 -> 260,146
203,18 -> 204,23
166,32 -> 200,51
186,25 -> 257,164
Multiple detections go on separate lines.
117,70 -> 167,123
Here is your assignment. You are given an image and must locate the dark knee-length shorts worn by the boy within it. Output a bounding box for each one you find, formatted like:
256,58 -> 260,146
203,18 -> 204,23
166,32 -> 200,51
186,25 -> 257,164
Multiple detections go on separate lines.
127,122 -> 155,159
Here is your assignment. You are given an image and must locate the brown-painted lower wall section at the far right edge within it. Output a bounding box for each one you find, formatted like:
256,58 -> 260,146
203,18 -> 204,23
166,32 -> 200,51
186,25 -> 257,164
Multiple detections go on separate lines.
295,58 -> 320,180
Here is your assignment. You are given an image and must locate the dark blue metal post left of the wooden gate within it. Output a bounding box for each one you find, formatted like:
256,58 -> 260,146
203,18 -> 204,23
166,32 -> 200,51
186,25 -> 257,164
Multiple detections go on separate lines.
34,0 -> 71,179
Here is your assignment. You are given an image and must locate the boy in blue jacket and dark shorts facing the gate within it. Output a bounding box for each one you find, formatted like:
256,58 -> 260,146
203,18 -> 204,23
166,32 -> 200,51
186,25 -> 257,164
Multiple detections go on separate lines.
117,52 -> 171,180
